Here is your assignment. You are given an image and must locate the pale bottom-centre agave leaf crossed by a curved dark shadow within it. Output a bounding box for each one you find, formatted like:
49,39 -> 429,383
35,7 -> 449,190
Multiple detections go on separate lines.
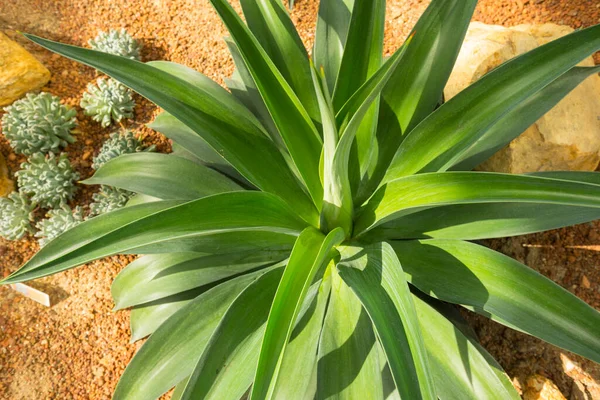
316,268 -> 385,400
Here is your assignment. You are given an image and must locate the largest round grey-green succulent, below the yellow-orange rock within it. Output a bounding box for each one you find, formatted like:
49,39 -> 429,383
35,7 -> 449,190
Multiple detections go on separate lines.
2,93 -> 77,155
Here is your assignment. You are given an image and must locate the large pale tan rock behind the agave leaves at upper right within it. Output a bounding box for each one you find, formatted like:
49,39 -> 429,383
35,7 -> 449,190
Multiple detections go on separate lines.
444,22 -> 600,173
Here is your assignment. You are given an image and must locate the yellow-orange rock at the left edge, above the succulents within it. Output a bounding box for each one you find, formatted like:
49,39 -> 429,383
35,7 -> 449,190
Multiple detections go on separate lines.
0,32 -> 50,106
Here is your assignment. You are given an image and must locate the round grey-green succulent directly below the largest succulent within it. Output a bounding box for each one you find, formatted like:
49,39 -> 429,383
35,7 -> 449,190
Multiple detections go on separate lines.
15,153 -> 79,208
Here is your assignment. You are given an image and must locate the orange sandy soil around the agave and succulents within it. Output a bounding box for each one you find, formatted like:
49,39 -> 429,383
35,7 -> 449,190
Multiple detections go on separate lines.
0,0 -> 600,400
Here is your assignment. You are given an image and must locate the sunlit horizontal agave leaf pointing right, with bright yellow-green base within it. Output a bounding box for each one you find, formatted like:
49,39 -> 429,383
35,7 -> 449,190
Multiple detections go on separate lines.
354,172 -> 600,235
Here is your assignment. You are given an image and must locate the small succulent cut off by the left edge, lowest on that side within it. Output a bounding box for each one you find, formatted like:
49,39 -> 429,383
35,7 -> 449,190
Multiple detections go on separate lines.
0,192 -> 35,240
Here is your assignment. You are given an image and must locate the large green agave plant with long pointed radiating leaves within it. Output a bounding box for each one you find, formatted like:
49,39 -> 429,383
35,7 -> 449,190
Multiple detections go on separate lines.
3,0 -> 600,400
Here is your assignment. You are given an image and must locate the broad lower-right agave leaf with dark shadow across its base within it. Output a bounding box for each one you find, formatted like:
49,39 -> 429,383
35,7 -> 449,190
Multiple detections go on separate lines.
392,239 -> 600,362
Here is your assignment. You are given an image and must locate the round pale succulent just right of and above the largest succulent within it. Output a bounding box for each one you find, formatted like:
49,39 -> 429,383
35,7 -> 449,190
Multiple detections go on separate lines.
80,78 -> 135,128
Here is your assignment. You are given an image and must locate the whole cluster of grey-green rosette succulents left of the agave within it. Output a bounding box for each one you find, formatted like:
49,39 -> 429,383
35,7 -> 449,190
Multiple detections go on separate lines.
0,29 -> 143,246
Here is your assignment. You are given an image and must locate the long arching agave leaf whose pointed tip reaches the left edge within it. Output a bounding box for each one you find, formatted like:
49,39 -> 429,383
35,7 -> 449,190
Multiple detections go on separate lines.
2,192 -> 305,284
